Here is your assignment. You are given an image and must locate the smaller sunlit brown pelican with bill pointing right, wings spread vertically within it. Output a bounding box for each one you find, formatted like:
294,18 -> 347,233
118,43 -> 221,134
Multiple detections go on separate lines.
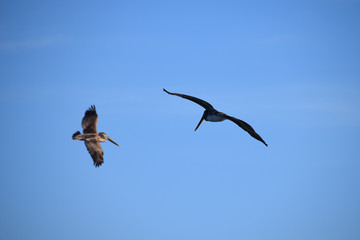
72,105 -> 120,167
